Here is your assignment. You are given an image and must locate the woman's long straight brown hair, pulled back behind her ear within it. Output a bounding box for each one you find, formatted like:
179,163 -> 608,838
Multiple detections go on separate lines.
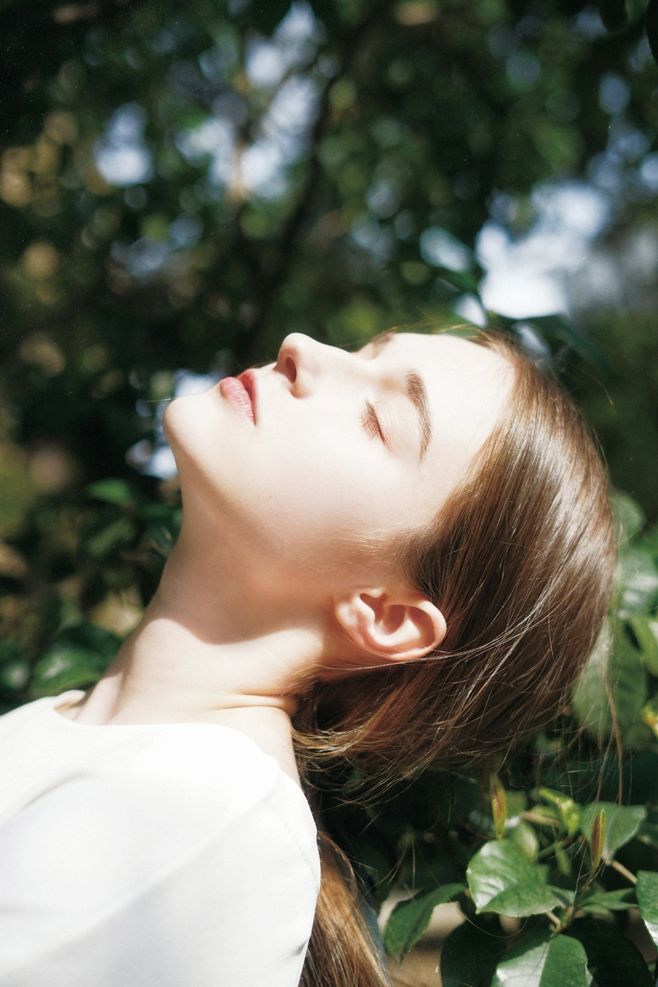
295,333 -> 615,987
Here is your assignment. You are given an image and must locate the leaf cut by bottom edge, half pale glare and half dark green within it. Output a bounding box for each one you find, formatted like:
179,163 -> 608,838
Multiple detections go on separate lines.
491,929 -> 591,987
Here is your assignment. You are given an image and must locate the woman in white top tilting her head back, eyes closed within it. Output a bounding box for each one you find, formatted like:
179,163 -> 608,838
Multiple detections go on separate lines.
0,333 -> 614,987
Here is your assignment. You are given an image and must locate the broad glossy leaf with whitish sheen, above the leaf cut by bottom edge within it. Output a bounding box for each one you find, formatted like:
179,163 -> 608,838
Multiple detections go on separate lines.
466,840 -> 565,918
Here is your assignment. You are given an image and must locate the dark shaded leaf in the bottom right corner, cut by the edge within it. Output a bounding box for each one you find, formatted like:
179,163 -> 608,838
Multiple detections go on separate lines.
568,915 -> 653,987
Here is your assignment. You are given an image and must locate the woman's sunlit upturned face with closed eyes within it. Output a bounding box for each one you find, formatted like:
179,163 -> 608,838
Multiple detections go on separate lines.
165,333 -> 512,596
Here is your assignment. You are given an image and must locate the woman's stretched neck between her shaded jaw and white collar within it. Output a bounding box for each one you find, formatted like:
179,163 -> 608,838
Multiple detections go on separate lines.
71,525 -> 322,731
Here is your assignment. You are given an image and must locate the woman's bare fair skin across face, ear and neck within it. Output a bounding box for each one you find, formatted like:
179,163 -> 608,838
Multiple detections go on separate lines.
57,333 -> 512,779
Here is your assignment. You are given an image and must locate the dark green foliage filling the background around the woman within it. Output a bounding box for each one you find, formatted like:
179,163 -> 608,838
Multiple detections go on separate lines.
0,0 -> 658,987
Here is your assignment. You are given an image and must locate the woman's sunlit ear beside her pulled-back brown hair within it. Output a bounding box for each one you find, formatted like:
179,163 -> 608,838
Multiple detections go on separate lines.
334,589 -> 446,662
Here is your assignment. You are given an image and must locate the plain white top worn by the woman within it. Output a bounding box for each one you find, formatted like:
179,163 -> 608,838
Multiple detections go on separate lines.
0,689 -> 320,987
